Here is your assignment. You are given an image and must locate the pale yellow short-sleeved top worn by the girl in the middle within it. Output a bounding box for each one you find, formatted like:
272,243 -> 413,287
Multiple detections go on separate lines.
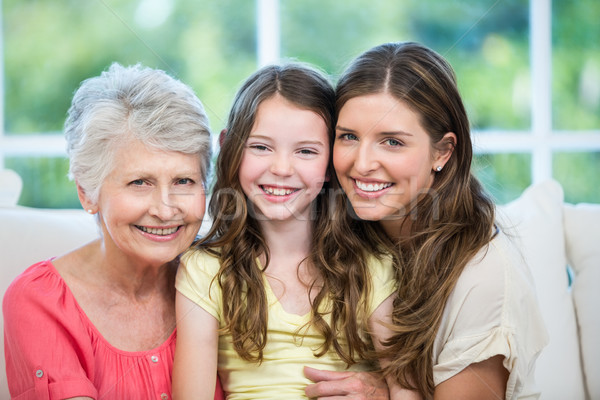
175,250 -> 396,400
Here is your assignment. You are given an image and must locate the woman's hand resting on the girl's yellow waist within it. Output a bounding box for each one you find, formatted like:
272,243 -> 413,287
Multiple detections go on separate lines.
304,367 -> 390,400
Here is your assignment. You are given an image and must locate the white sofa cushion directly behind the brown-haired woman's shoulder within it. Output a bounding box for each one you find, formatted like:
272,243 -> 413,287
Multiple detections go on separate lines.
498,181 -> 585,399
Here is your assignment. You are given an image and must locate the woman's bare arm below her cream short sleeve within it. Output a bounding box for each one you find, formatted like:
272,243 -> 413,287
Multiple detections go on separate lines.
433,355 -> 508,400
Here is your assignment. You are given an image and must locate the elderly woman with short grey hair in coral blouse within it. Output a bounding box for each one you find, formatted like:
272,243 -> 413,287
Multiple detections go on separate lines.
3,64 -> 222,400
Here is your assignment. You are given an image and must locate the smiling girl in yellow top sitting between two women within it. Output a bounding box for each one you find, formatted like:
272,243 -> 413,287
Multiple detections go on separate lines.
173,64 -> 404,399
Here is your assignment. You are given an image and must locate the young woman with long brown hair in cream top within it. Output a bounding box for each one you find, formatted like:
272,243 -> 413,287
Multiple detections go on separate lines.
307,43 -> 548,399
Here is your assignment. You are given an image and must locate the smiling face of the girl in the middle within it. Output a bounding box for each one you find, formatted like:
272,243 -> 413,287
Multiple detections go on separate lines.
239,94 -> 329,221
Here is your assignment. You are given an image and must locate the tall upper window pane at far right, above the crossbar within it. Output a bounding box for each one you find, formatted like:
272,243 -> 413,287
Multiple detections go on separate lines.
552,0 -> 600,130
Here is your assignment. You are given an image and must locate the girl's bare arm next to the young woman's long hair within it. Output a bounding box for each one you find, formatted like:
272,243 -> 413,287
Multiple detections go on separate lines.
369,295 -> 421,400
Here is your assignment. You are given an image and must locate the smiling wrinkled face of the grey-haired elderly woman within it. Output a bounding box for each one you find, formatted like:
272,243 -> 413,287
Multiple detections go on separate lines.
97,141 -> 206,265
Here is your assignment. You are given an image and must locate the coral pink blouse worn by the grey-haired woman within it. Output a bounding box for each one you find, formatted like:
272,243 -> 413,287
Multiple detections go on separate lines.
2,260 -> 224,400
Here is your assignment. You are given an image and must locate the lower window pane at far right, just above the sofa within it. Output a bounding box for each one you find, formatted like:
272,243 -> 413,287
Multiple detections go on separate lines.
552,152 -> 600,203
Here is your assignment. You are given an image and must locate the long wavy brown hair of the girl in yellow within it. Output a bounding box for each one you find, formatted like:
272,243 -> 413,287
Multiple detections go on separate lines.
197,63 -> 384,365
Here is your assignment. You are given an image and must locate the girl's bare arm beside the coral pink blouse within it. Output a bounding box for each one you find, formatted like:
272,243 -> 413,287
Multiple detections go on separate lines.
173,291 -> 219,400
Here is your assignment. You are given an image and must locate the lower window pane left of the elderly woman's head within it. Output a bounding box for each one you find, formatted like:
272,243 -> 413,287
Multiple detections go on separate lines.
5,157 -> 81,208
